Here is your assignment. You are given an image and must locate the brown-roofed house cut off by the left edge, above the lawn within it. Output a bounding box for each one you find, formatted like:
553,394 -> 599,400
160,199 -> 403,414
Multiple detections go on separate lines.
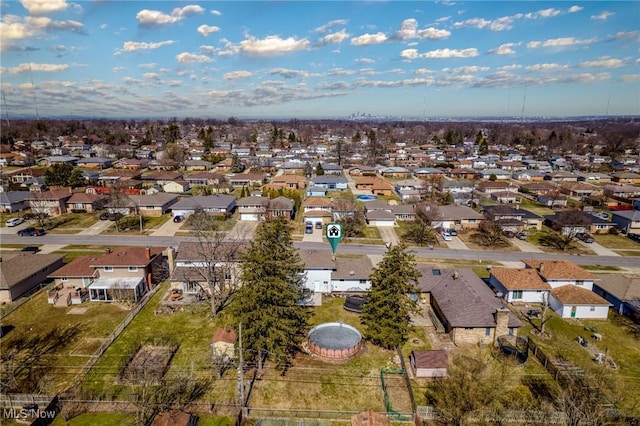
0,252 -> 64,303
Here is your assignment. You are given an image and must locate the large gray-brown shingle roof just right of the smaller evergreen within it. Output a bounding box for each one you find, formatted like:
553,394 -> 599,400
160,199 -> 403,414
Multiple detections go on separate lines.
418,268 -> 523,327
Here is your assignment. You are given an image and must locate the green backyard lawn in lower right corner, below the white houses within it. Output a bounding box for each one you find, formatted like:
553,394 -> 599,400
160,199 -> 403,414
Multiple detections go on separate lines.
520,310 -> 640,416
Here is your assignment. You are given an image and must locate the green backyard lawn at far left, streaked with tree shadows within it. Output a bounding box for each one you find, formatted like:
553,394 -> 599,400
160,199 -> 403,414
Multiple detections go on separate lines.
0,291 -> 127,393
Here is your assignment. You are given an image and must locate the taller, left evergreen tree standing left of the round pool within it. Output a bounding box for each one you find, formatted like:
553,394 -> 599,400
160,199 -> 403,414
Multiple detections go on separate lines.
230,218 -> 309,370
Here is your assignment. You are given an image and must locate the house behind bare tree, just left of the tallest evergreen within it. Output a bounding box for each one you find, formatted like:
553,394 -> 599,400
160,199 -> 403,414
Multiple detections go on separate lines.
167,240 -> 246,295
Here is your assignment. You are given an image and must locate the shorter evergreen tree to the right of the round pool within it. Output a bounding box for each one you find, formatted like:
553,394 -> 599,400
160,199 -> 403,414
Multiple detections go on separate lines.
362,245 -> 420,349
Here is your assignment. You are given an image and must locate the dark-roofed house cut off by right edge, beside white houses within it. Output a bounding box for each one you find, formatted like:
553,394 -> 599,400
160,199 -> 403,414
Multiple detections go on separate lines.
593,274 -> 640,317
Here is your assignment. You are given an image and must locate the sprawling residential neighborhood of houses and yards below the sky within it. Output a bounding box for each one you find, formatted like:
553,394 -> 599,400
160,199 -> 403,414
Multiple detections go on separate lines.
0,121 -> 640,424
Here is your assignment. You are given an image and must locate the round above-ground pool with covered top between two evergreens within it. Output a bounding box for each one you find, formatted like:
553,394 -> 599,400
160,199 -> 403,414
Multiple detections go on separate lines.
309,322 -> 363,359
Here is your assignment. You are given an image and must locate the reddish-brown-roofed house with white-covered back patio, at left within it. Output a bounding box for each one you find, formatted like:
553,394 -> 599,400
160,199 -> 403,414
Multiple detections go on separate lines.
89,247 -> 164,302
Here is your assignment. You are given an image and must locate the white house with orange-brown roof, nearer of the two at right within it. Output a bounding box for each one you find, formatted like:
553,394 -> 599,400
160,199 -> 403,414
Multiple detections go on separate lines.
549,285 -> 611,319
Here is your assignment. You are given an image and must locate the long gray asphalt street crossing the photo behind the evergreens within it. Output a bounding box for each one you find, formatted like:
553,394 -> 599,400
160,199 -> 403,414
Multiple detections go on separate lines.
0,234 -> 640,268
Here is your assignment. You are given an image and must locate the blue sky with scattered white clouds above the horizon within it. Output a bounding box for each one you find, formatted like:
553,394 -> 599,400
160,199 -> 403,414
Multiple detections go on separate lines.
0,0 -> 640,119
